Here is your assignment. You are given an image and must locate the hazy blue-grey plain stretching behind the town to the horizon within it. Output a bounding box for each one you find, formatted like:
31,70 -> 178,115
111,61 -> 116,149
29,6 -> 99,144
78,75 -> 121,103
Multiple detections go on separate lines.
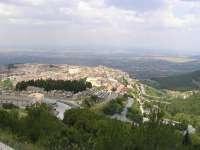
0,50 -> 200,79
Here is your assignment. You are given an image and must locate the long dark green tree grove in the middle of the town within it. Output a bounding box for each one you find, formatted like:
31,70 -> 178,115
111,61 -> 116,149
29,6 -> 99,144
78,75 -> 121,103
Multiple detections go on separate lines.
16,79 -> 92,93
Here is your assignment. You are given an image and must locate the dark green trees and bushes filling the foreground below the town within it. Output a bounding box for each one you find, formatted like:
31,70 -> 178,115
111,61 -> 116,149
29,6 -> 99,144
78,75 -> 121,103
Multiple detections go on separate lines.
0,104 -> 198,150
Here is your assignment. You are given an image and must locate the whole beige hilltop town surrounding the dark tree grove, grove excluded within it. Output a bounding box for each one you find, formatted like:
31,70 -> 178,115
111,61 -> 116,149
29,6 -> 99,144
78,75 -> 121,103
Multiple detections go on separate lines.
0,64 -> 137,115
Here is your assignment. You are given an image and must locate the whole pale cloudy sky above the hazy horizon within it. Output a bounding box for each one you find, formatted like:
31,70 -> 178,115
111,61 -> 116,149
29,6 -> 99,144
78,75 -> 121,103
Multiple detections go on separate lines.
0,0 -> 200,52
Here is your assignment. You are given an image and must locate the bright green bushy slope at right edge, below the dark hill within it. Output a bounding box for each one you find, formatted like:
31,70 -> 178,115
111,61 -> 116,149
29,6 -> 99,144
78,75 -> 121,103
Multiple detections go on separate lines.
163,93 -> 200,144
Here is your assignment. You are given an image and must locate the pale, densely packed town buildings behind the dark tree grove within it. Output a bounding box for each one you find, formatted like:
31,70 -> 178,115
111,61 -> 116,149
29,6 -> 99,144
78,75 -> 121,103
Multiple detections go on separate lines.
1,64 -> 135,93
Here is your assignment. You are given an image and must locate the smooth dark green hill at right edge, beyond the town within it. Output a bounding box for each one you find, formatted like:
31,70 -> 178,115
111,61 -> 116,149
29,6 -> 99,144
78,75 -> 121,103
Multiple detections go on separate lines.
151,70 -> 200,91
